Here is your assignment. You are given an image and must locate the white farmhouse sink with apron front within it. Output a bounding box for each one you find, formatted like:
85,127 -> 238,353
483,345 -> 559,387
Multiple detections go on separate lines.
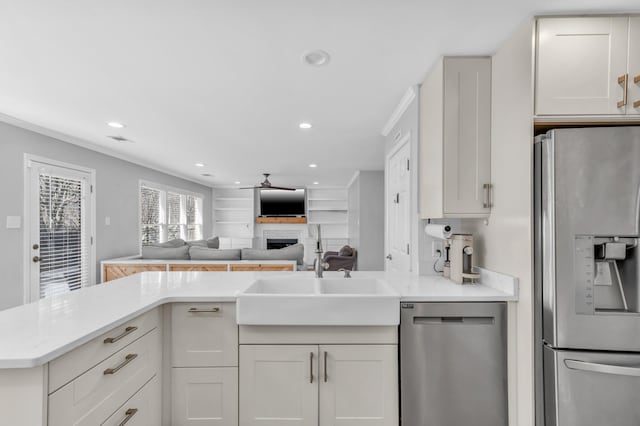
236,277 -> 400,326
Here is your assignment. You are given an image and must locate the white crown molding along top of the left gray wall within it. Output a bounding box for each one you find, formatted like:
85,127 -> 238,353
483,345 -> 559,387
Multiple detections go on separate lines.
0,113 -> 213,188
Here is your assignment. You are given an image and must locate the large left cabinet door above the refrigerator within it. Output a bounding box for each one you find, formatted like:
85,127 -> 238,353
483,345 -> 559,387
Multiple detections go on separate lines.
536,17 -> 629,115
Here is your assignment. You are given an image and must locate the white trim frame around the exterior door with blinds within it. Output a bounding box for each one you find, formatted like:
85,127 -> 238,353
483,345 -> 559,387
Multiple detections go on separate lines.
22,153 -> 97,303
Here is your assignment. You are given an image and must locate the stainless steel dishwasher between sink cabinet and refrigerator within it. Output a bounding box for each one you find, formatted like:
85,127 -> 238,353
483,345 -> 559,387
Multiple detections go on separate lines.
400,302 -> 508,426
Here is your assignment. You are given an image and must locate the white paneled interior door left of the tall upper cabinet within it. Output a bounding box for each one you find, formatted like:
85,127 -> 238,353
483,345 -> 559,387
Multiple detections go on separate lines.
385,138 -> 411,272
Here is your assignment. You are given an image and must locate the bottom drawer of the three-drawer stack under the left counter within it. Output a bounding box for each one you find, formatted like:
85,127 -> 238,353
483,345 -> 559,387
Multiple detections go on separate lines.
101,376 -> 162,426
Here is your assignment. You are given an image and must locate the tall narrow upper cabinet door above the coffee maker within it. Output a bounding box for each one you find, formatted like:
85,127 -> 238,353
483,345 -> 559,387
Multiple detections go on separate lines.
444,58 -> 491,217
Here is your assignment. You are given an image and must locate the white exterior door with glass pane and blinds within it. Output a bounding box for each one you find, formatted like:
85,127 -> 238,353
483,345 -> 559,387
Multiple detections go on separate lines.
27,160 -> 94,301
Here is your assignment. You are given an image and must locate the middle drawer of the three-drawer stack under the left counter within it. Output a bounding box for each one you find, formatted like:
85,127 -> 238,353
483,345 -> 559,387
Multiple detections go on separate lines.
49,329 -> 162,426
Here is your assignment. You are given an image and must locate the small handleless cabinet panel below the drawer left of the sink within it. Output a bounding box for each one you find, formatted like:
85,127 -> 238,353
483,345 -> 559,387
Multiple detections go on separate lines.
171,367 -> 238,426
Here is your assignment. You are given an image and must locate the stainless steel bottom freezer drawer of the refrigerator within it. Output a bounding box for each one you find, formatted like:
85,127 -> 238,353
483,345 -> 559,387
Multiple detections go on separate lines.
544,347 -> 640,426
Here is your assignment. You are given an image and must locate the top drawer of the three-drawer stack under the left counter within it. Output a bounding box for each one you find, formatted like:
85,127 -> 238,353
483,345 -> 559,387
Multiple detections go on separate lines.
49,309 -> 160,393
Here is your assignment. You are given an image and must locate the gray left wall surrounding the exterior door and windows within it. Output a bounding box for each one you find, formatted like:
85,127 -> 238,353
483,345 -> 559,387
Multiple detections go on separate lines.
0,123 -> 212,309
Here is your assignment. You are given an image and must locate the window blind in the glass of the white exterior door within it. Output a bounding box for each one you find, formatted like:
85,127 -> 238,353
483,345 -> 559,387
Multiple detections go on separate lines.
38,171 -> 91,297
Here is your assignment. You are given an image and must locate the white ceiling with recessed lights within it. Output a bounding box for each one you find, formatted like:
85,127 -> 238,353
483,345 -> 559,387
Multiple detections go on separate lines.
0,0 -> 638,185
